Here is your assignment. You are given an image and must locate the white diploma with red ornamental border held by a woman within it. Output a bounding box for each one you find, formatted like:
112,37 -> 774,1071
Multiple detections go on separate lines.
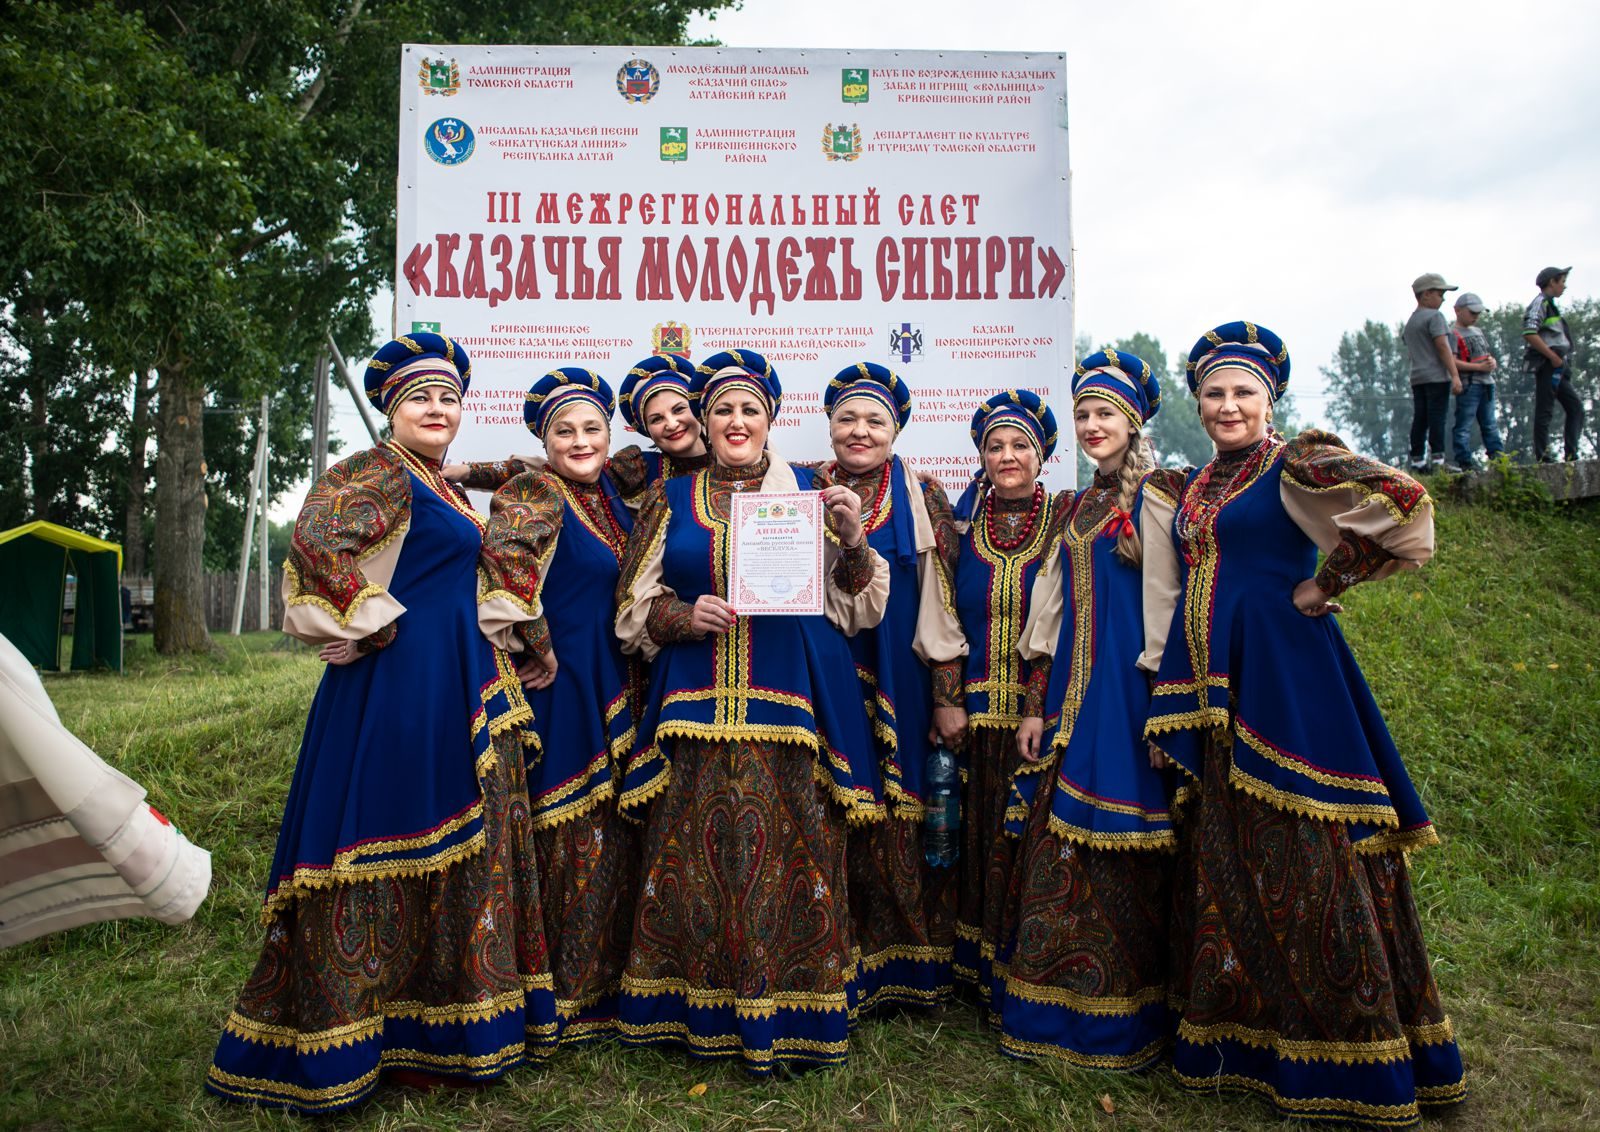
728,491 -> 824,614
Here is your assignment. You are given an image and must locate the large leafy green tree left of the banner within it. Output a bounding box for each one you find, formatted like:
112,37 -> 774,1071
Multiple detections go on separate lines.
0,0 -> 730,652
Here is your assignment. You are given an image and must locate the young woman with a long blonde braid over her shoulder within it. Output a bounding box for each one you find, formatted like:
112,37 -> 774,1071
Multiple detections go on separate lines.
994,350 -> 1176,1070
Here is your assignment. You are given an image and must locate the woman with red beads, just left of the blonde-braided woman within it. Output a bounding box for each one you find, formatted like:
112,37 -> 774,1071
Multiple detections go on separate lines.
955,389 -> 1064,1002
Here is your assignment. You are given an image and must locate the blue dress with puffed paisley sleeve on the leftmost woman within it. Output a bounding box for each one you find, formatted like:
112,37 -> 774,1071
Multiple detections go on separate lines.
206,443 -> 555,1113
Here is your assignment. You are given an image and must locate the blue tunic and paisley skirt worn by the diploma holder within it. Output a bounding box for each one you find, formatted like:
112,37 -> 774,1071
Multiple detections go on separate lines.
619,460 -> 882,1076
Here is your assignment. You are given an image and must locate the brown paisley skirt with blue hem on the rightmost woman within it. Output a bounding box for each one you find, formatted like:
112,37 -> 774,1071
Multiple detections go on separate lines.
1171,732 -> 1466,1127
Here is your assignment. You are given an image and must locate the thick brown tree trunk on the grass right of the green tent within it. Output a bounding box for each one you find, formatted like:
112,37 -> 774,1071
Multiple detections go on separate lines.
155,361 -> 211,656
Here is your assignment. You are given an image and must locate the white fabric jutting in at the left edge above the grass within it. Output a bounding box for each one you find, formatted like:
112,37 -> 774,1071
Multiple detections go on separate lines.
0,636 -> 211,947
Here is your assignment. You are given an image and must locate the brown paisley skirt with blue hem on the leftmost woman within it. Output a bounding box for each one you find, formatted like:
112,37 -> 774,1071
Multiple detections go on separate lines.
206,729 -> 555,1113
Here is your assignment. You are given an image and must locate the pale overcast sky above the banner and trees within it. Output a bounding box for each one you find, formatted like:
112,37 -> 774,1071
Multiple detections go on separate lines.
302,0 -> 1600,518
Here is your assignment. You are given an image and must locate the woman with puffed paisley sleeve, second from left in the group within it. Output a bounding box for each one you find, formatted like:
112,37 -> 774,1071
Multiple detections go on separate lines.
478,366 -> 638,1042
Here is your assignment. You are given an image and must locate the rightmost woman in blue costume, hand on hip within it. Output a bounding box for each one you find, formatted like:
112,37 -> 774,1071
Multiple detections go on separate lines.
1144,321 -> 1466,1127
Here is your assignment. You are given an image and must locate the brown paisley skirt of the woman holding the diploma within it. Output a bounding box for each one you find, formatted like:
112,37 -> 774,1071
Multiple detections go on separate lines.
618,739 -> 858,1076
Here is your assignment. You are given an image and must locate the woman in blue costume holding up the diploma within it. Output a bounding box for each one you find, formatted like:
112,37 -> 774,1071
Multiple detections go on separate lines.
616,350 -> 888,1074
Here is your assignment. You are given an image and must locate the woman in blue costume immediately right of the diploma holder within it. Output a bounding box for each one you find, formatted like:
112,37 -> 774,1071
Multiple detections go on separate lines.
822,361 -> 966,1009
